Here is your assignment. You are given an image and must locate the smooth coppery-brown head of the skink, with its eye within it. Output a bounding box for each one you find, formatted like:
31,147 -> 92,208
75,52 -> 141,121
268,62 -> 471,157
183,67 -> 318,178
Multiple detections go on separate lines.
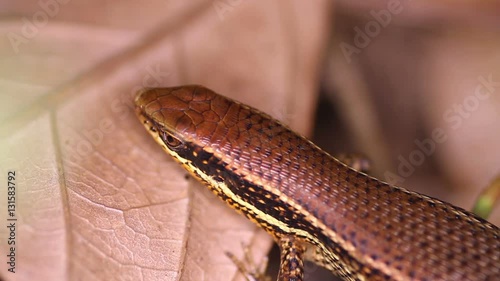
135,85 -> 242,160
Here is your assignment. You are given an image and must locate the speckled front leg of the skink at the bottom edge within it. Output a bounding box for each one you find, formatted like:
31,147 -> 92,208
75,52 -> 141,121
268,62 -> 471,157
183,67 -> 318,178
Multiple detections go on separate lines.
278,236 -> 306,281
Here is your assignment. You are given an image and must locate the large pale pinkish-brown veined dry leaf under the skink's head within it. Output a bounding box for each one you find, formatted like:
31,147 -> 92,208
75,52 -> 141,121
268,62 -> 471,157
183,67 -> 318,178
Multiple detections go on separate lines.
0,0 -> 328,281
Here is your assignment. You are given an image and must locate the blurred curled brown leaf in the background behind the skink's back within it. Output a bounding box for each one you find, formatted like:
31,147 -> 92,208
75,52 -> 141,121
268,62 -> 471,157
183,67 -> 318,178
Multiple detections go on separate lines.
321,1 -> 500,225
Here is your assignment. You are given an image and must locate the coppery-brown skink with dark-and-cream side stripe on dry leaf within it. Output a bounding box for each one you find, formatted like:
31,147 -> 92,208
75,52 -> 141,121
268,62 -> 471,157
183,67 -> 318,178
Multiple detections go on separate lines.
135,85 -> 500,281
